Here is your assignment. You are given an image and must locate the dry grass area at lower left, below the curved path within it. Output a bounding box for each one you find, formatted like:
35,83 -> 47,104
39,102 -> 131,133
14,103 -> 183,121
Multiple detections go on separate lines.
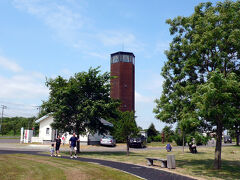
0,154 -> 138,180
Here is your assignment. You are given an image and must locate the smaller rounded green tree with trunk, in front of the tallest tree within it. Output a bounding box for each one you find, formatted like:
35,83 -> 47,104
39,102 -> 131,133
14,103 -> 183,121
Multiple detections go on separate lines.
193,71 -> 240,169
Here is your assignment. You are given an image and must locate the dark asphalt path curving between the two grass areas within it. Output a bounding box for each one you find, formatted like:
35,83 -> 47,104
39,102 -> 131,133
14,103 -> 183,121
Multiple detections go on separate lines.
0,150 -> 193,180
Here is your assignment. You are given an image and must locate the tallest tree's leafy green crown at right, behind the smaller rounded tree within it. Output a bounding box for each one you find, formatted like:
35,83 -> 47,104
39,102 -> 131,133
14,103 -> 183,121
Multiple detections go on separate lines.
154,1 -> 240,169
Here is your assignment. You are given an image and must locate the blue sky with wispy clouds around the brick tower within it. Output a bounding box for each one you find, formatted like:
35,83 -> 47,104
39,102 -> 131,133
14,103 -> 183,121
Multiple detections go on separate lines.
0,0 -> 221,130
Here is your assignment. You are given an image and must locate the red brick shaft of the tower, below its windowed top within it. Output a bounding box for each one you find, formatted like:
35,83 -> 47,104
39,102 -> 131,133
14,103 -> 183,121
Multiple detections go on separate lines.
110,62 -> 135,111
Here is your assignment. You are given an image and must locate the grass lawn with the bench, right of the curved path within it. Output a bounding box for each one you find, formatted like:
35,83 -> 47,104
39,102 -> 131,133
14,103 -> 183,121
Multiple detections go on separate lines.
67,146 -> 240,179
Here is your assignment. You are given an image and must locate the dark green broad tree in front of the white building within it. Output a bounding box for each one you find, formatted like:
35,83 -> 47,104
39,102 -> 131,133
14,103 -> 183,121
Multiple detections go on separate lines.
42,68 -> 120,151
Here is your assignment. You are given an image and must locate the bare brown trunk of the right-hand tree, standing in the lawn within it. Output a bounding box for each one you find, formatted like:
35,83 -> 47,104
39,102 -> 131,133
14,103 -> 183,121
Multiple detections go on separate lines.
214,122 -> 223,169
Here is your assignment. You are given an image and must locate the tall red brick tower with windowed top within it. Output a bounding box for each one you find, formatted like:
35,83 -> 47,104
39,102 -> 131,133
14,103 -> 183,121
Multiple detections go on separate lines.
110,51 -> 135,111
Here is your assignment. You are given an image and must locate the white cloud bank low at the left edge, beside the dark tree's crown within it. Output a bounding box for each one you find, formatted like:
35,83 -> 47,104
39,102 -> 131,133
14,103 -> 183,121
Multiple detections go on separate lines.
0,56 -> 48,117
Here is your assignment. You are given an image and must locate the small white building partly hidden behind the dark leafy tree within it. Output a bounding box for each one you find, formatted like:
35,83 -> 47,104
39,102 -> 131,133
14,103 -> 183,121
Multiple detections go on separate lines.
32,114 -> 113,145
